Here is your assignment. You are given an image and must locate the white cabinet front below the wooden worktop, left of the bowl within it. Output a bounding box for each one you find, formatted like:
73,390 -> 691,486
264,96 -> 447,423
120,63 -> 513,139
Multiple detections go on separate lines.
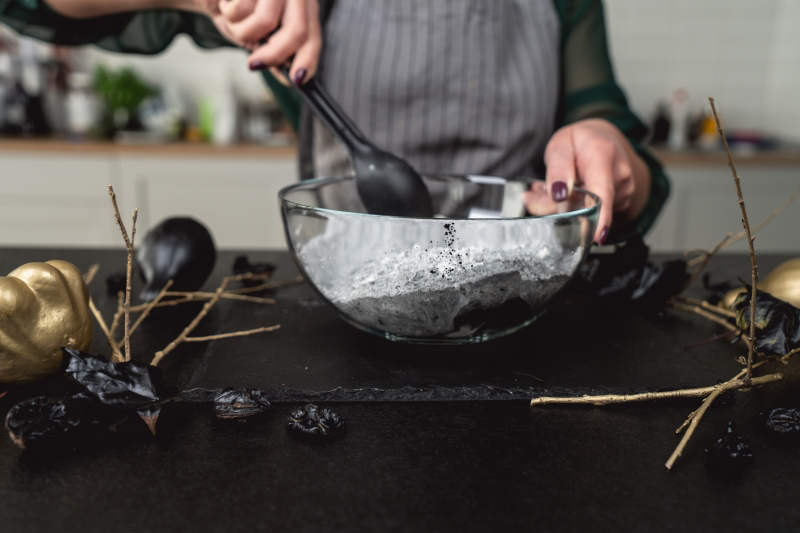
0,141 -> 297,249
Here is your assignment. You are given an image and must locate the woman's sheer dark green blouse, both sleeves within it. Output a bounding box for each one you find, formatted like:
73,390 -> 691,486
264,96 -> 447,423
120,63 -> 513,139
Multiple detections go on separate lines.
0,0 -> 669,242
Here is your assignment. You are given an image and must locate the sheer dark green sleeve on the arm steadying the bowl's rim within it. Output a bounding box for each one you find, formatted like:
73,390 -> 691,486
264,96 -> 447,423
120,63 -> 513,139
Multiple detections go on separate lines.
555,0 -> 670,243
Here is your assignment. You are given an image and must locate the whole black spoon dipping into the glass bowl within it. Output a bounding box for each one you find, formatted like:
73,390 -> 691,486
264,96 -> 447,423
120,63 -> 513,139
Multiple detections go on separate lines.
281,66 -> 433,218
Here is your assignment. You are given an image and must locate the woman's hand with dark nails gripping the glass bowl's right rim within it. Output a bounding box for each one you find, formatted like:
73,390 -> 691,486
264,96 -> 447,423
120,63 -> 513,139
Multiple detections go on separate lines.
526,119 -> 650,244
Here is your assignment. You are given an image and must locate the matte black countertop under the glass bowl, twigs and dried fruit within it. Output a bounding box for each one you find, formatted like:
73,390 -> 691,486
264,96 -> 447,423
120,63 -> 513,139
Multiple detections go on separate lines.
0,249 -> 800,532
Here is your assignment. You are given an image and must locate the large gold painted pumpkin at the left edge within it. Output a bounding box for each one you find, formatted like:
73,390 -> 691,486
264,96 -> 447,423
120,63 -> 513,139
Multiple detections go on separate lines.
0,261 -> 92,384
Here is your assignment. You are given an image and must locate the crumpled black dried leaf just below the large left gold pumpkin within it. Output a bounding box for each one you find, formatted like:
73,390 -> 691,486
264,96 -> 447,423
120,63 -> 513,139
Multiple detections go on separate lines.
62,348 -> 178,410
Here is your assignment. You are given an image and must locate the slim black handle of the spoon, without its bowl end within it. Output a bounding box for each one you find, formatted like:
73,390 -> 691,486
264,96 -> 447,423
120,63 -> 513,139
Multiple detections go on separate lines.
280,65 -> 374,154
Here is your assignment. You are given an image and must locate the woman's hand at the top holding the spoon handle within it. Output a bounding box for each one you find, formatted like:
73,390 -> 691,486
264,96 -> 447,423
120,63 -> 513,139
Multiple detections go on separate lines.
193,0 -> 322,85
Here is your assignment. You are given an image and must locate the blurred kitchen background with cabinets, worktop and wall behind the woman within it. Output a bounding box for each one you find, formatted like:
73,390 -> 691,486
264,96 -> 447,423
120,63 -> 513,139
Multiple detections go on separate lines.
0,0 -> 800,253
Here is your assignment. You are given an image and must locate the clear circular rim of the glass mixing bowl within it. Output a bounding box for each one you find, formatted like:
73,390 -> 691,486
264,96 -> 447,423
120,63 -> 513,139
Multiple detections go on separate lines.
278,174 -> 602,222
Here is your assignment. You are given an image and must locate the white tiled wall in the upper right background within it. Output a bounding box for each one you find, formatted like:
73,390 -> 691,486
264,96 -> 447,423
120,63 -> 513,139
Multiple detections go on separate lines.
605,0 -> 800,141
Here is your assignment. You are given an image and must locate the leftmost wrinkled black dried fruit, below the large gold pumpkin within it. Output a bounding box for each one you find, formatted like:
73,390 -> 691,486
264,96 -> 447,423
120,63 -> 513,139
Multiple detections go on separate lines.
6,396 -> 97,450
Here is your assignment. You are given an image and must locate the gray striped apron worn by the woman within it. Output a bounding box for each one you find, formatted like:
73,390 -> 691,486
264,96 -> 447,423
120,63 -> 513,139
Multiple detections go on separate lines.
301,0 -> 560,181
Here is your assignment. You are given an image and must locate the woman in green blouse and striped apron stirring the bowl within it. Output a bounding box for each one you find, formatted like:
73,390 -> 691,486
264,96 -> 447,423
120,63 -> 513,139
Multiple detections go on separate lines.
0,0 -> 669,244
